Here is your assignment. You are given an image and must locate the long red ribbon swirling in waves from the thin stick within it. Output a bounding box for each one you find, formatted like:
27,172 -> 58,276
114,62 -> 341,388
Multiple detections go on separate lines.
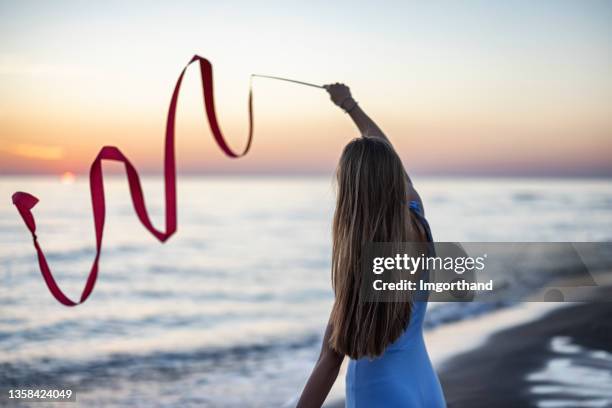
13,55 -> 253,306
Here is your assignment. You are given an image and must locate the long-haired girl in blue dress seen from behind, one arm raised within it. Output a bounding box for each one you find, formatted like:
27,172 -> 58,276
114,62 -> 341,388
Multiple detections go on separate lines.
297,83 -> 445,408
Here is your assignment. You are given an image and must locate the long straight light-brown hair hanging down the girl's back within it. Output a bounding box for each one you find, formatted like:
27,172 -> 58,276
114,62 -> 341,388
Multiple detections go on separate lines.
329,137 -> 421,359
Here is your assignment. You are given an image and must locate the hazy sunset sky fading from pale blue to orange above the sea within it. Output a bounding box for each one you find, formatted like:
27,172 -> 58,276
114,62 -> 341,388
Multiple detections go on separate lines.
0,0 -> 612,177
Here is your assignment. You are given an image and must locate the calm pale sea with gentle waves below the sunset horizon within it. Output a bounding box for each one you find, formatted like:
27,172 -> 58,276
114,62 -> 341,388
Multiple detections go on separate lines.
0,176 -> 612,407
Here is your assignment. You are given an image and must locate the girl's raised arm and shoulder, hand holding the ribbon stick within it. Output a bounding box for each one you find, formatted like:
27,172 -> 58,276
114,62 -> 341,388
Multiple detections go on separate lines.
325,83 -> 423,208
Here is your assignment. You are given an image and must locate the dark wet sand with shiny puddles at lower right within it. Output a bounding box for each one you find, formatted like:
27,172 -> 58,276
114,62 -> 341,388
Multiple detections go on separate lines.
439,287 -> 612,408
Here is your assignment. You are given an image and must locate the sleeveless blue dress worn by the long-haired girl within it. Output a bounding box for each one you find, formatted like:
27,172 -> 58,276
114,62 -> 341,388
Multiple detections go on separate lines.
346,201 -> 446,408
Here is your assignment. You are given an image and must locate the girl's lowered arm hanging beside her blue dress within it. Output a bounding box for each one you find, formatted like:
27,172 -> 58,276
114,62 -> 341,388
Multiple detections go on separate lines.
296,324 -> 344,408
